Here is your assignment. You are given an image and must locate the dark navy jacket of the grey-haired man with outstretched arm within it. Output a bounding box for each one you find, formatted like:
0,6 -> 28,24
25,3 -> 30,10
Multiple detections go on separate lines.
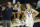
2,7 -> 17,20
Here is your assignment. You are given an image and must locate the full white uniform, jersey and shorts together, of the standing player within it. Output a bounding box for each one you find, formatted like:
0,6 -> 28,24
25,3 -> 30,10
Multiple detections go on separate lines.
26,9 -> 33,27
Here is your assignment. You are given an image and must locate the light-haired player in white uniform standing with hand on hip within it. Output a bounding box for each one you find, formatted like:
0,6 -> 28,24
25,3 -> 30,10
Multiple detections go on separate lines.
25,4 -> 39,27
